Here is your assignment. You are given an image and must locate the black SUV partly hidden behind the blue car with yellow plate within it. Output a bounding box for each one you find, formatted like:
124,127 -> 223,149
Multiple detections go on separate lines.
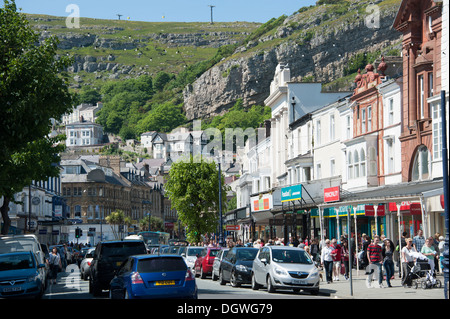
89,240 -> 147,296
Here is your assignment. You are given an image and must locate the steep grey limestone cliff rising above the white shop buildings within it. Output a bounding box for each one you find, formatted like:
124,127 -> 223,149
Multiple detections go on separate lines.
183,0 -> 401,119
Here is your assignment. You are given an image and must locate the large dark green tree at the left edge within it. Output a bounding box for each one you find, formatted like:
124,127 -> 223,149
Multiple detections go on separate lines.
0,0 -> 73,234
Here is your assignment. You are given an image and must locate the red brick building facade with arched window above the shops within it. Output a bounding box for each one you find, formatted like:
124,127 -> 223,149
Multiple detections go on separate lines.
393,0 -> 442,182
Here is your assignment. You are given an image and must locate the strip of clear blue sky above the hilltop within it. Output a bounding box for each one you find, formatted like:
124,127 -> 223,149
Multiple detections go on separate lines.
16,0 -> 316,22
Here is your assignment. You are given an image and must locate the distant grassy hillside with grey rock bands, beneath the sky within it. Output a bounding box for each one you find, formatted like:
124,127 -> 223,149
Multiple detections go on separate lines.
27,14 -> 260,89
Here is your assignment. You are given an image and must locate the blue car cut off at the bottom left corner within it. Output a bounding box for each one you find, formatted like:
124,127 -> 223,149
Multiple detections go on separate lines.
0,251 -> 45,298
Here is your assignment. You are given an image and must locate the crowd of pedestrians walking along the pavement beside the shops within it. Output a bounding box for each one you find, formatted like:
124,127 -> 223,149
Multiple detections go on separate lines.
198,229 -> 444,288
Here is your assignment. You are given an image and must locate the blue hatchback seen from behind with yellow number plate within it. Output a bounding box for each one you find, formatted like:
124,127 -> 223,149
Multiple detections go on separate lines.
109,255 -> 197,299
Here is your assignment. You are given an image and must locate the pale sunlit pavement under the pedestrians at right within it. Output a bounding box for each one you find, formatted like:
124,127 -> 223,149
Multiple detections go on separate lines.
320,269 -> 445,299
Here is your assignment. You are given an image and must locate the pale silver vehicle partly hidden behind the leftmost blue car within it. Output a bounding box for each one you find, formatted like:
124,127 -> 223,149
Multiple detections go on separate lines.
0,234 -> 50,288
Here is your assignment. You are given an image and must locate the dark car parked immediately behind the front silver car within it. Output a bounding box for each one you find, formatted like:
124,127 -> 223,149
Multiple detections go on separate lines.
219,247 -> 259,287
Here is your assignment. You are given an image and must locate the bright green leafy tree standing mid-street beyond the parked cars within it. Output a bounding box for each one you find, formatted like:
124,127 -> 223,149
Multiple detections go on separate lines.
165,156 -> 228,242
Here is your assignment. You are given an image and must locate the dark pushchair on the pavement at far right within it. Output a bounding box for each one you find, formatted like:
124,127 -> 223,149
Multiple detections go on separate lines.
406,253 -> 442,289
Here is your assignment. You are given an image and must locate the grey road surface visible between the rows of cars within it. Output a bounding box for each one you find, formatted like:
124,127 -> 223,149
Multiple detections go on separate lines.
43,264 -> 330,300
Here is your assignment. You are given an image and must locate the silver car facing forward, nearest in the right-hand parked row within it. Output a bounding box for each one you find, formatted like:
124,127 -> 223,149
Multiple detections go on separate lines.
252,246 -> 320,295
